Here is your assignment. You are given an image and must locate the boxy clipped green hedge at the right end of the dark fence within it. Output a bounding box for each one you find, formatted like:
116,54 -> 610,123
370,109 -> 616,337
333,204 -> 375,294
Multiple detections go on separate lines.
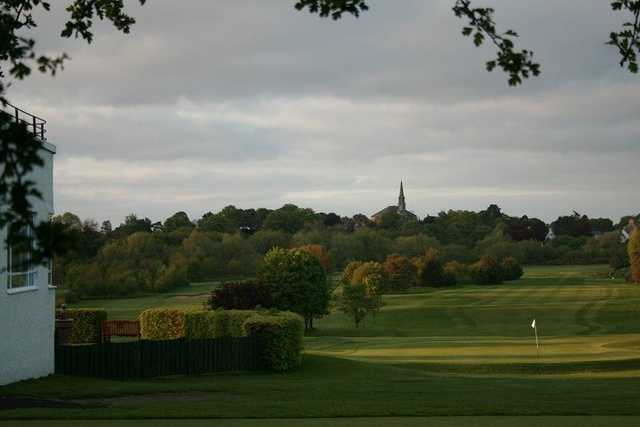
244,312 -> 304,372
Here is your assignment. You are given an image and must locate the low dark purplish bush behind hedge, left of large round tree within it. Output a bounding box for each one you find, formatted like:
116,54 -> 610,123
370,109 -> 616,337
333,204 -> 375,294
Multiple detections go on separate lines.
207,280 -> 272,310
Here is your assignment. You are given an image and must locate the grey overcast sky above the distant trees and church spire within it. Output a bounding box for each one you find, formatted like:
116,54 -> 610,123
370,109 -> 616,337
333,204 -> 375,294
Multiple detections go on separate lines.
9,0 -> 640,223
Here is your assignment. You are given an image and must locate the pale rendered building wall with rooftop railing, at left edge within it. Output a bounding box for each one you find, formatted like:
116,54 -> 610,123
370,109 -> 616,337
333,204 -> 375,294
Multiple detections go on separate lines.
0,108 -> 56,385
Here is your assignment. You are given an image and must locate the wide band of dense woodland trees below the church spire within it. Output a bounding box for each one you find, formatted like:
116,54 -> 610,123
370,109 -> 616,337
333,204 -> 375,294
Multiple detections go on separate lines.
54,205 -> 640,298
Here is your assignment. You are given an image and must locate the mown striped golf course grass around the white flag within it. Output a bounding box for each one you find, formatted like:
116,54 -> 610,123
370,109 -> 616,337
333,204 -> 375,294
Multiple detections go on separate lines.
0,266 -> 640,427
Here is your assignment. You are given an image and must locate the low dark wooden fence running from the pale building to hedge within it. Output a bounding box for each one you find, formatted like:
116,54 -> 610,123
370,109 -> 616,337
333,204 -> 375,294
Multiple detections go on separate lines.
55,337 -> 262,379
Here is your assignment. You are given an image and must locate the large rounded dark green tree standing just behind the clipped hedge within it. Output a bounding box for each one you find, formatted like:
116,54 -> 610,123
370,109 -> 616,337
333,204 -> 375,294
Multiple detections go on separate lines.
258,248 -> 329,330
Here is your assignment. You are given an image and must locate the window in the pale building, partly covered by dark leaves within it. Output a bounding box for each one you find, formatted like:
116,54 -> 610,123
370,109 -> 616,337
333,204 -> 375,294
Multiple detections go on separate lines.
7,227 -> 37,289
